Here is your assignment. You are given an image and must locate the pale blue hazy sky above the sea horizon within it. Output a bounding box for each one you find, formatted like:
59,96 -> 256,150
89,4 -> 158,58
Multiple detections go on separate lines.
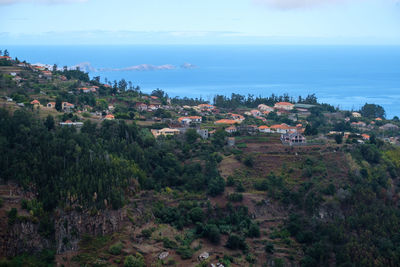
0,0 -> 400,45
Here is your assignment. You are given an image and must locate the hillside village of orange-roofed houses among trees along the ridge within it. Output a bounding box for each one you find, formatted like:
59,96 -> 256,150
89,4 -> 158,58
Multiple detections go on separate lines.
0,53 -> 399,146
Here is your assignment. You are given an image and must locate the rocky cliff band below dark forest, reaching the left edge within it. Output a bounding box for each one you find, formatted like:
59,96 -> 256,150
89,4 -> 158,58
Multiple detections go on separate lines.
0,210 -> 127,257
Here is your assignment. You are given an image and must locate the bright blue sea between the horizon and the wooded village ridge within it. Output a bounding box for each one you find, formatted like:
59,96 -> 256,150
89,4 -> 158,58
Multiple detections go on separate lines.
7,46 -> 400,118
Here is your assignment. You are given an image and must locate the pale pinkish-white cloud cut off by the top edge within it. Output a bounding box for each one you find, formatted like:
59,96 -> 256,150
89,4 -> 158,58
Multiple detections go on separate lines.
252,0 -> 400,9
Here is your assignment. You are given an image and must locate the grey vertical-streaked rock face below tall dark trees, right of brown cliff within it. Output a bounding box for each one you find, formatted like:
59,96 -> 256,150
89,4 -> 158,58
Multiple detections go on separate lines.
55,210 -> 127,253
